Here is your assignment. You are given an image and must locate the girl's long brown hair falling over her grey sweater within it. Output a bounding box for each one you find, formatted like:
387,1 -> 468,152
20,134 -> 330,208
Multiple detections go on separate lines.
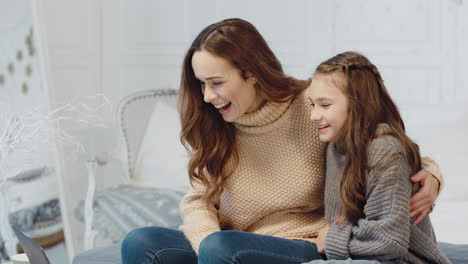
315,52 -> 421,223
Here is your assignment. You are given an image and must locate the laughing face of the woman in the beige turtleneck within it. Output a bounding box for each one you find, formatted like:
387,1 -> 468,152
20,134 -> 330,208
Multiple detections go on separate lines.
192,50 -> 264,122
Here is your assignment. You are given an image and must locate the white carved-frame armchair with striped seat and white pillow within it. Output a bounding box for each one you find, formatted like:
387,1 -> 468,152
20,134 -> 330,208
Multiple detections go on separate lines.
75,90 -> 190,250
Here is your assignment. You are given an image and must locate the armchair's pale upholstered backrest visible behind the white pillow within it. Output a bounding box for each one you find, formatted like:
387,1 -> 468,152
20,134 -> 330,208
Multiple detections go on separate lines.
118,89 -> 177,178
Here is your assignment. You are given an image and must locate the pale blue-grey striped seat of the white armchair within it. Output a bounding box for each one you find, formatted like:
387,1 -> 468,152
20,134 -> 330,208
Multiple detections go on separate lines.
75,185 -> 184,243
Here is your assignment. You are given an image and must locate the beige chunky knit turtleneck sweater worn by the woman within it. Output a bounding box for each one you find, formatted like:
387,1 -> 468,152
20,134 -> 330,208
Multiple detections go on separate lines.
180,89 -> 438,252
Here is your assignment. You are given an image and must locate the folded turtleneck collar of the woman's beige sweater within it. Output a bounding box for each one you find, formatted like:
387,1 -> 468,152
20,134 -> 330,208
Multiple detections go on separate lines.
234,100 -> 291,127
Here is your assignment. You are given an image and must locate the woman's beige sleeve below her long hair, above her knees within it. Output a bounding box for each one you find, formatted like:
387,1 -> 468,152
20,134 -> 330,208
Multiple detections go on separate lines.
180,179 -> 221,254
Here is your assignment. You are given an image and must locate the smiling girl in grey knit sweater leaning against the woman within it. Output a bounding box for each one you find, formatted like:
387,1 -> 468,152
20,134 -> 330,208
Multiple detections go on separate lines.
309,52 -> 450,263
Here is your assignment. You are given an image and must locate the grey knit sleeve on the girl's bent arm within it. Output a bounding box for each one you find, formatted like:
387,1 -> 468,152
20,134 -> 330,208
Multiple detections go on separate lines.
325,140 -> 412,260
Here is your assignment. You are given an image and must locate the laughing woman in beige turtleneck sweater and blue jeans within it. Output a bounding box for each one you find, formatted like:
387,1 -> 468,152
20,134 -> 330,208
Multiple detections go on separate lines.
122,19 -> 439,264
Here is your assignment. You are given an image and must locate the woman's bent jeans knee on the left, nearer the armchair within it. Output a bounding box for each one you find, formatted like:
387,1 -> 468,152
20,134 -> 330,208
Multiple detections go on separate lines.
121,227 -> 197,264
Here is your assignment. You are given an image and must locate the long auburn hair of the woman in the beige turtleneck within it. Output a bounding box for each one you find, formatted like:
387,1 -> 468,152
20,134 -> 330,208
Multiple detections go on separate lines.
178,18 -> 310,205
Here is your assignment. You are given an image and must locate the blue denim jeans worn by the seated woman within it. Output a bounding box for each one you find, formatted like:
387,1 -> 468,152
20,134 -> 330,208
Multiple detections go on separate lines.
122,227 -> 322,264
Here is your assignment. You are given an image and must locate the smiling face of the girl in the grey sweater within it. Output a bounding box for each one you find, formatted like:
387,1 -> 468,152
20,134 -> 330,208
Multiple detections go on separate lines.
308,73 -> 348,142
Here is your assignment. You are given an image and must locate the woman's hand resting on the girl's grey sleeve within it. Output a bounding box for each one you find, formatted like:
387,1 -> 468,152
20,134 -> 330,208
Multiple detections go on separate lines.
410,170 -> 440,226
